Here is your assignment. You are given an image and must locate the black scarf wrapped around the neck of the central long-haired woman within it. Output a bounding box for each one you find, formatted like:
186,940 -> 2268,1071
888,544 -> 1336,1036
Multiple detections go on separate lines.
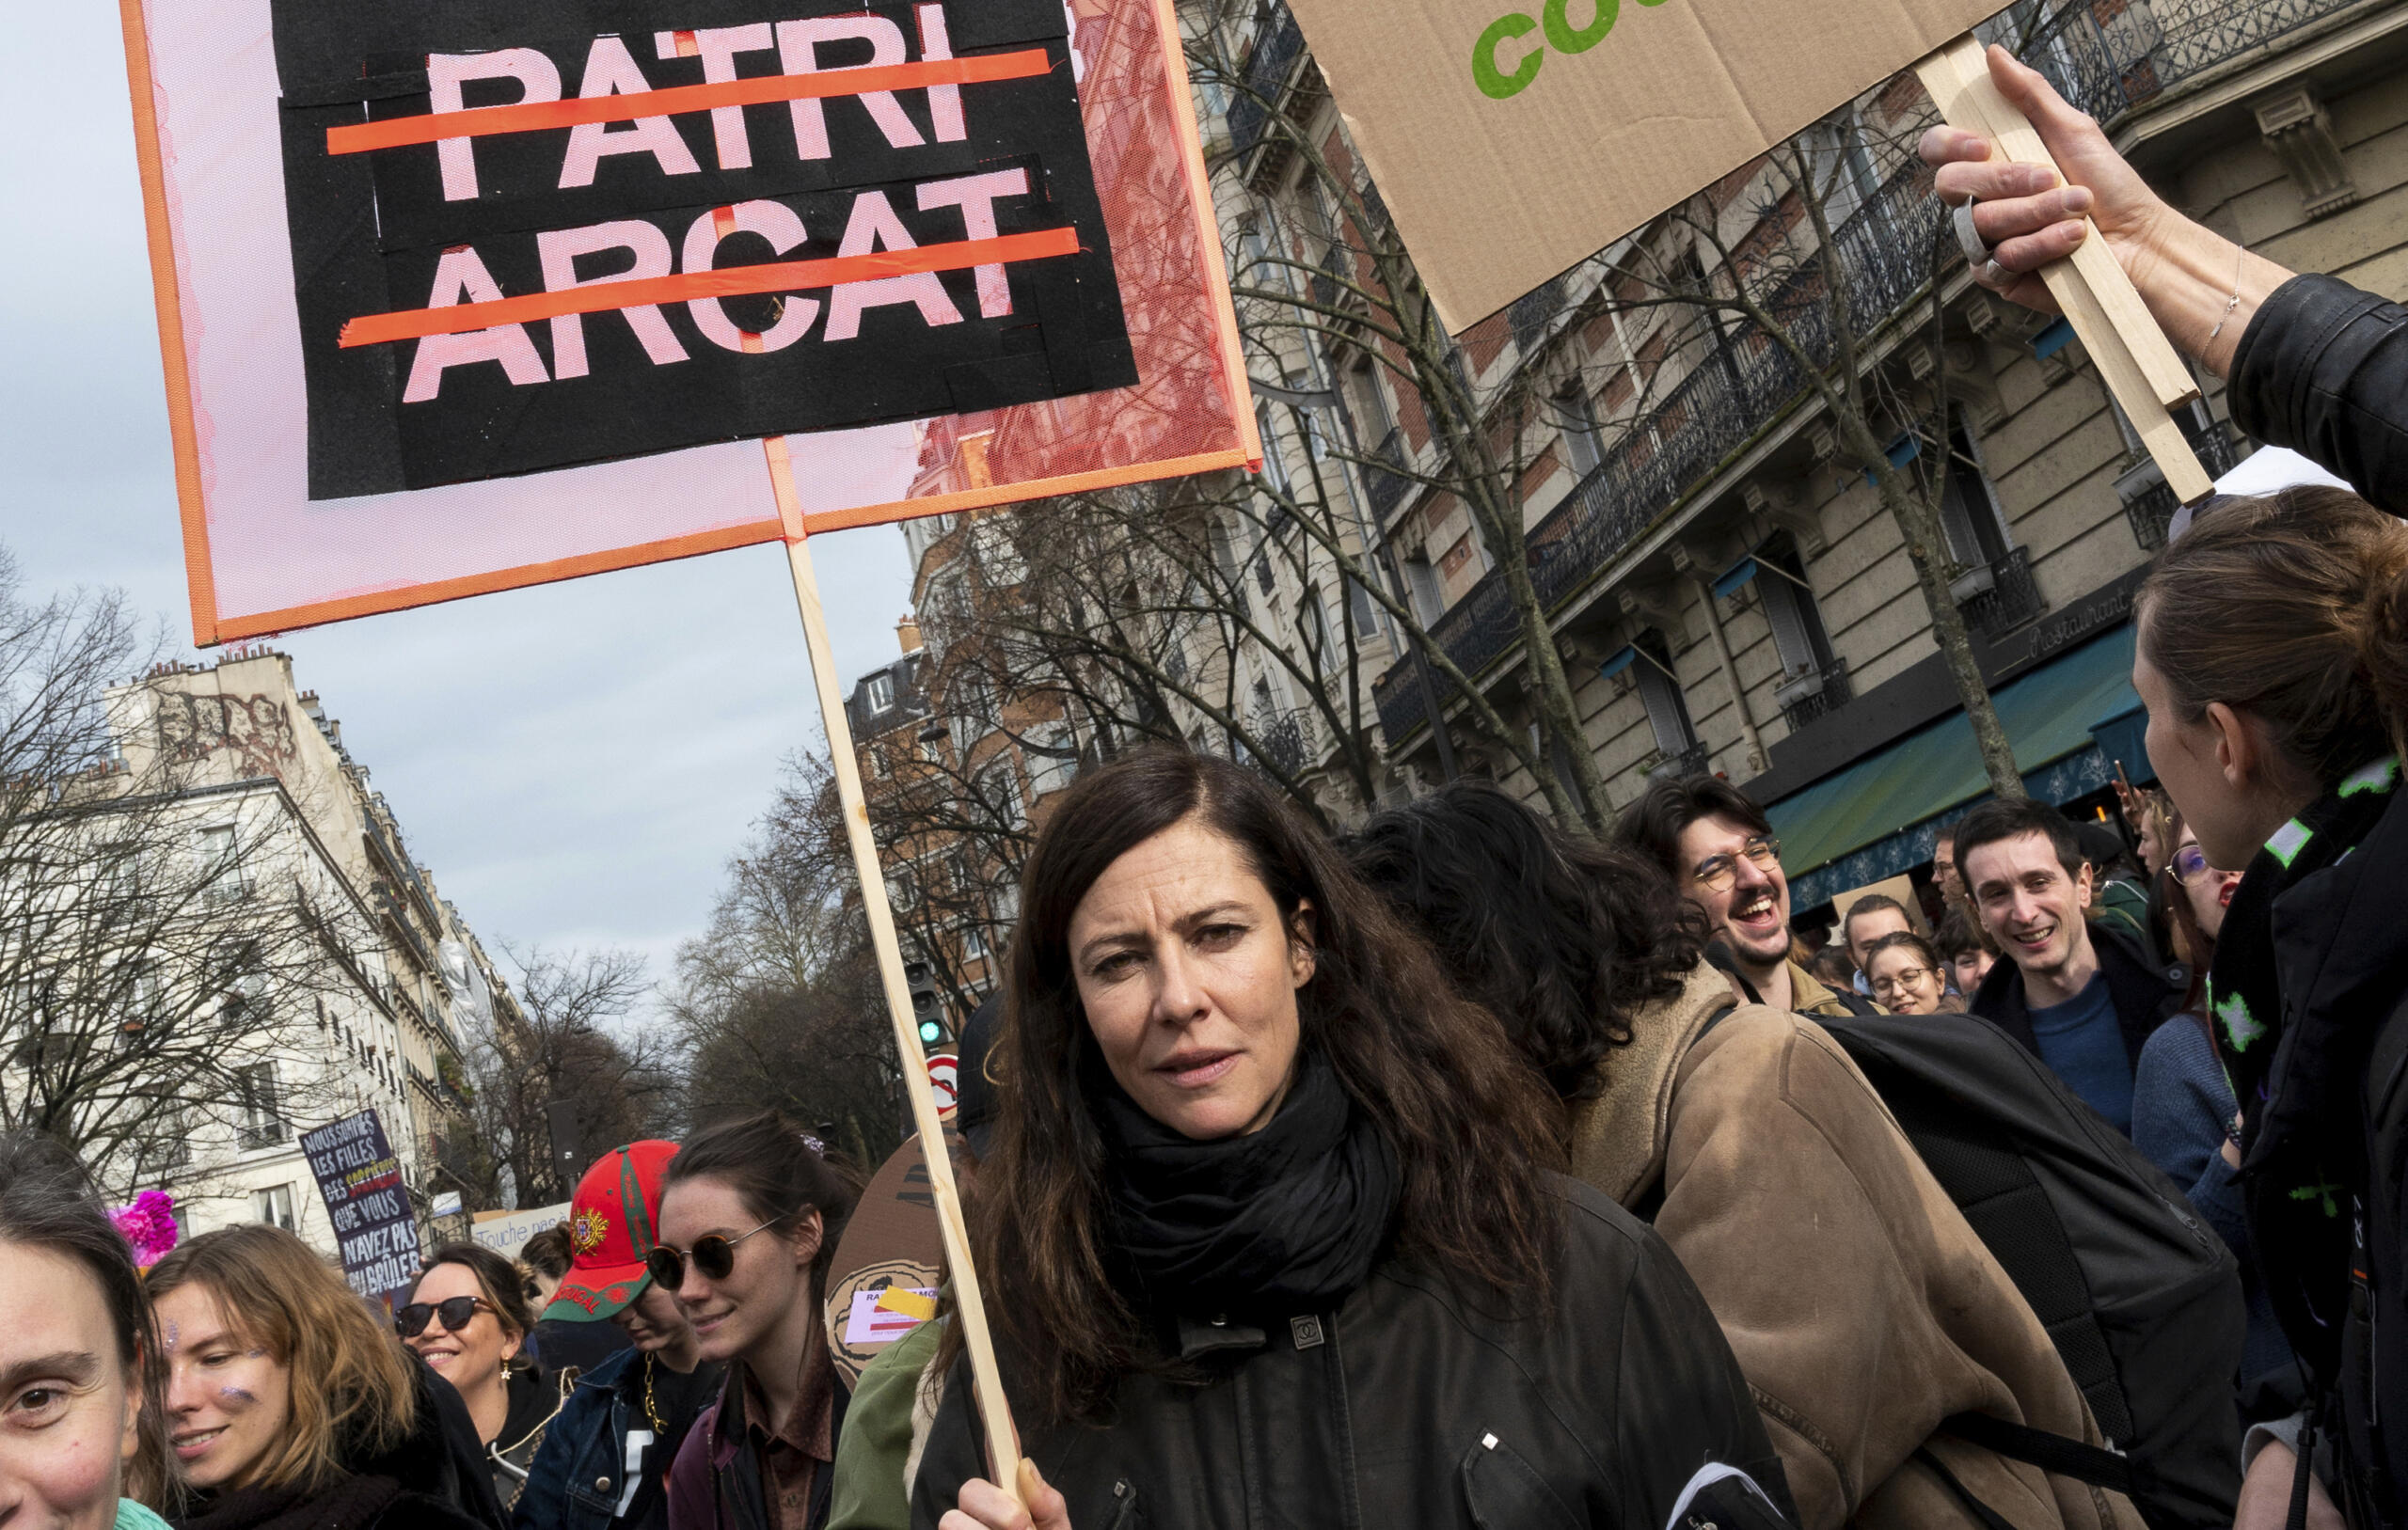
1088,1049 -> 1399,1316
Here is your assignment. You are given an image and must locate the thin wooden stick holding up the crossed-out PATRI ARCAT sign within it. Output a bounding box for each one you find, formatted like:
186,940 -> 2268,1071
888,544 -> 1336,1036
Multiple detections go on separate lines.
761,435 -> 1021,1499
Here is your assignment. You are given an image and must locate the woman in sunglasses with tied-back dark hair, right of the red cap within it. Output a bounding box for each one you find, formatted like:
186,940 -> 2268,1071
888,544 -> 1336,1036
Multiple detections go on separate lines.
645,1112 -> 860,1530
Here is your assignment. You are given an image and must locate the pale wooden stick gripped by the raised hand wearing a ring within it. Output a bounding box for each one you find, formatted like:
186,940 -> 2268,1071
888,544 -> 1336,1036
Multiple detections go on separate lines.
1914,34 -> 2215,505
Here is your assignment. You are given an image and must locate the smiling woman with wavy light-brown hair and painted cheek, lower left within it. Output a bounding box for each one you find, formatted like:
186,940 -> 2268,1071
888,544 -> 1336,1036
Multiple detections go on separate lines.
145,1222 -> 491,1530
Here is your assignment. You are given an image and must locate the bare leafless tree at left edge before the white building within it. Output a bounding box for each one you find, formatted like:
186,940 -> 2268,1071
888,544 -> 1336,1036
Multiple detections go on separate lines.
0,548 -> 380,1191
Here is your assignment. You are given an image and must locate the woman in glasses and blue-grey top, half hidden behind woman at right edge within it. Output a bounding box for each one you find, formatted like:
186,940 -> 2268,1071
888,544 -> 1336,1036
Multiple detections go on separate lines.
2131,811 -> 2300,1422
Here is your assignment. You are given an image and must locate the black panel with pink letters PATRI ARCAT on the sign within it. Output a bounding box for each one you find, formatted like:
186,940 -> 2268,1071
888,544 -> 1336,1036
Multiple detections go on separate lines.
275,0 -> 1136,498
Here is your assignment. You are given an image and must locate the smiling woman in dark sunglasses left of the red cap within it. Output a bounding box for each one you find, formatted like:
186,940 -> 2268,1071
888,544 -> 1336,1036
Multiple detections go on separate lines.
409,1244 -> 576,1511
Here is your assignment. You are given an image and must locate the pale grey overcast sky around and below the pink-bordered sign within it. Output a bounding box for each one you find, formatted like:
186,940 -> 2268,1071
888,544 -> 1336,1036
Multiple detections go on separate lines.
0,3 -> 911,996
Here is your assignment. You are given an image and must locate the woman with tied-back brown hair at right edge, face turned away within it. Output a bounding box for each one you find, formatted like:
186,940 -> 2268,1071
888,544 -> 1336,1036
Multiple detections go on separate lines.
2131,488 -> 2408,1527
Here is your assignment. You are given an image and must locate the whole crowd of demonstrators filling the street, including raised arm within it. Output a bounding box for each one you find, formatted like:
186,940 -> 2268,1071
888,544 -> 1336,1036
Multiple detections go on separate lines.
0,41 -> 2408,1530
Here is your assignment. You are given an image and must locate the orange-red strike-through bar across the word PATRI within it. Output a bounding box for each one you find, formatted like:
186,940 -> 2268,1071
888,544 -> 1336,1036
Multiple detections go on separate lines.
325,48 -> 1050,154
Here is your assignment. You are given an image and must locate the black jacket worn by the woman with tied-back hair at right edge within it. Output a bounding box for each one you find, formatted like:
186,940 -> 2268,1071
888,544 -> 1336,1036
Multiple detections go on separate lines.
2242,792 -> 2408,1530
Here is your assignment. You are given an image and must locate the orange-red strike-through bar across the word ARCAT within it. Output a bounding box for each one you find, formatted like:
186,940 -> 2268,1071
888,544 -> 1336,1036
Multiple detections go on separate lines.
340,226 -> 1079,349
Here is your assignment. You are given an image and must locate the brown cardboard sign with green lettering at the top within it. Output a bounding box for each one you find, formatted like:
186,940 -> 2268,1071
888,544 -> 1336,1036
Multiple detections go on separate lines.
1291,0 -> 1999,335
